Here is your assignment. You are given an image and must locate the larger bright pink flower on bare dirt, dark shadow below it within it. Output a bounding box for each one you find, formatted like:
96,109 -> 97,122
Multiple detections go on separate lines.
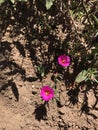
40,86 -> 54,101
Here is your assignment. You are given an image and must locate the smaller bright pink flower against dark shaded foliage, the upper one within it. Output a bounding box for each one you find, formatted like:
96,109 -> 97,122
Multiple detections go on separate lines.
58,55 -> 70,67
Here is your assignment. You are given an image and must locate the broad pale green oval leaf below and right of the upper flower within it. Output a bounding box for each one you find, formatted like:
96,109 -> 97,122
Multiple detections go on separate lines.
75,70 -> 87,83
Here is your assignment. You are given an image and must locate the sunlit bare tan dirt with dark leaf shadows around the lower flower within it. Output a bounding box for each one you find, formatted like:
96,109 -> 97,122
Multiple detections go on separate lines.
0,31 -> 98,130
